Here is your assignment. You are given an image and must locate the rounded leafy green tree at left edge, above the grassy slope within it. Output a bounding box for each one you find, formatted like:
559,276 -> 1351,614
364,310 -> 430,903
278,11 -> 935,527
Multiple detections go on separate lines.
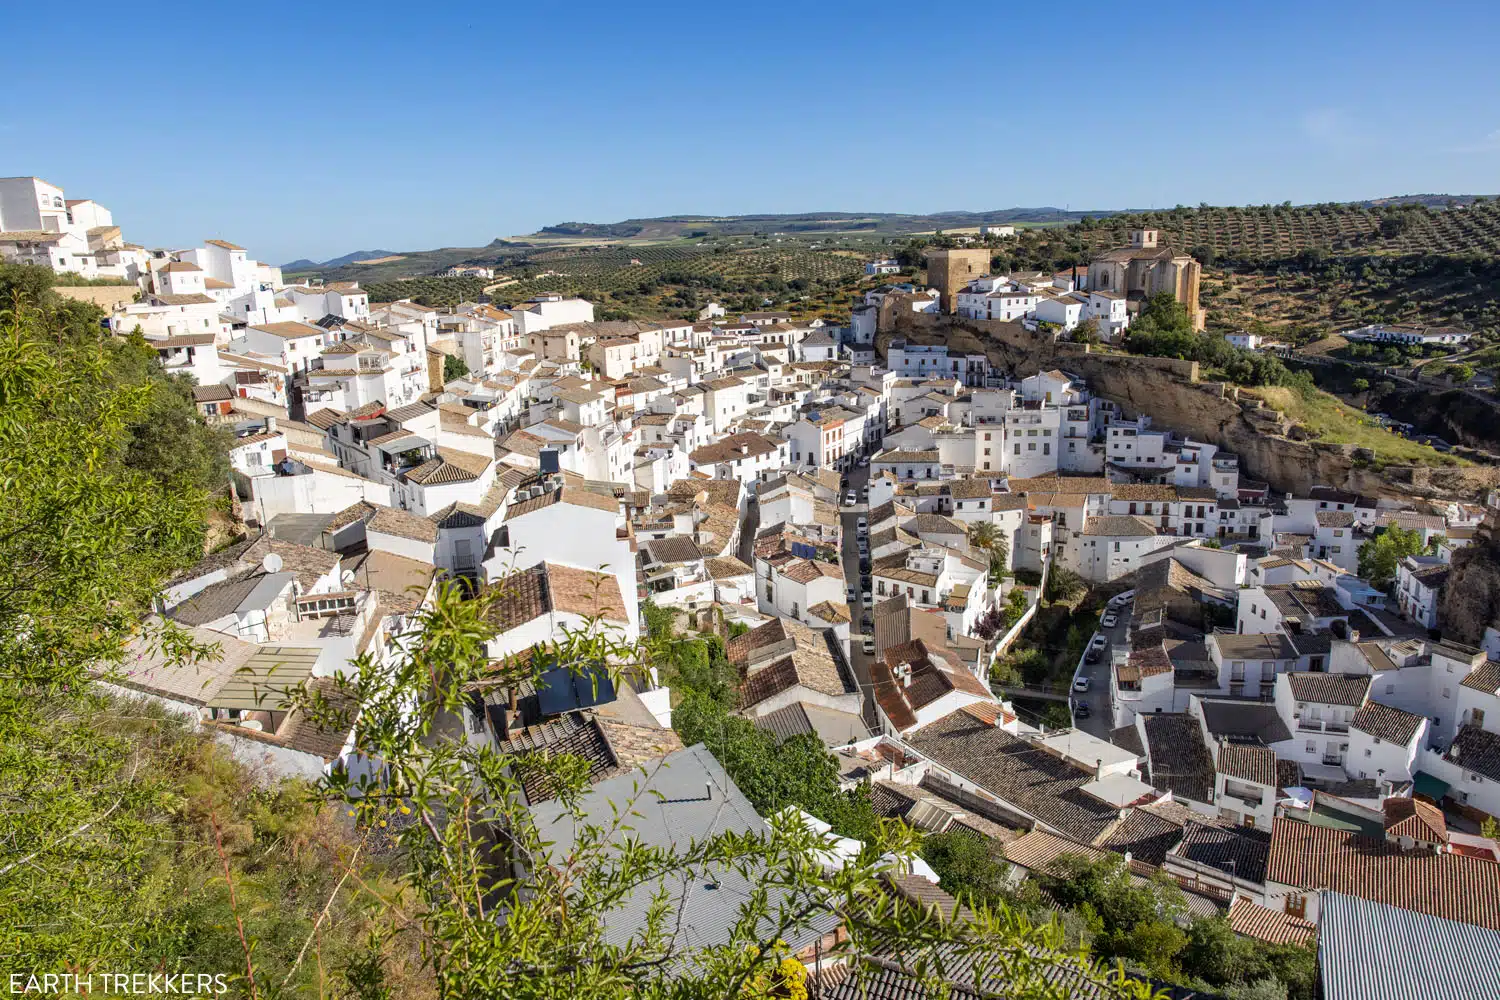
0,295 -> 222,694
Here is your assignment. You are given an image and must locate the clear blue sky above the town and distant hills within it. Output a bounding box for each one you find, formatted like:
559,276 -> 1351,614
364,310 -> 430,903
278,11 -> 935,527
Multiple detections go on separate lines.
0,0 -> 1500,262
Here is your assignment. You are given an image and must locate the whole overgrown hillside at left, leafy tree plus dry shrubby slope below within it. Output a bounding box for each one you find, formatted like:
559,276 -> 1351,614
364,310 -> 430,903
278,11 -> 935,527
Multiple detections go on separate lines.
0,287 -> 431,997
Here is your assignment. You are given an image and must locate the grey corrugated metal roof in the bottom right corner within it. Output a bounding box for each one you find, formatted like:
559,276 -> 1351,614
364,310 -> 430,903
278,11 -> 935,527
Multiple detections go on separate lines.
1317,892 -> 1500,1000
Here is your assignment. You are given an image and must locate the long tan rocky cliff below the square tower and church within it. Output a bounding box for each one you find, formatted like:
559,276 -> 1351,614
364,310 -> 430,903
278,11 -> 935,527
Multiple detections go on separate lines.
878,316 -> 1500,499
